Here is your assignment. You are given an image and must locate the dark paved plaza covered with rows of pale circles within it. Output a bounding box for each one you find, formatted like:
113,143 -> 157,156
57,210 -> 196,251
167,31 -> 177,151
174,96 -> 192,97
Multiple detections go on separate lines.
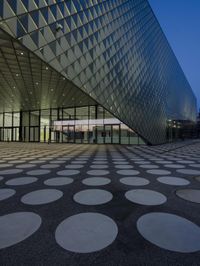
0,141 -> 200,266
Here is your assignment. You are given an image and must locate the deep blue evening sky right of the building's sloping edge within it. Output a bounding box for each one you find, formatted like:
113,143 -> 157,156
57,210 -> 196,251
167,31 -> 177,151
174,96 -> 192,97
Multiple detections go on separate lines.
149,0 -> 200,108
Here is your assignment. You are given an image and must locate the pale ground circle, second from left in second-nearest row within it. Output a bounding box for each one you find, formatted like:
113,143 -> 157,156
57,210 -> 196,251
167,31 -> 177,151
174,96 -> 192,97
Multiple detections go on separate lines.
21,189 -> 63,205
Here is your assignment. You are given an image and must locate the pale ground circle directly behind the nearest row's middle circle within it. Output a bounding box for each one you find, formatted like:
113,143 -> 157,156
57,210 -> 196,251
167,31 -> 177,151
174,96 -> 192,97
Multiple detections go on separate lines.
73,189 -> 113,205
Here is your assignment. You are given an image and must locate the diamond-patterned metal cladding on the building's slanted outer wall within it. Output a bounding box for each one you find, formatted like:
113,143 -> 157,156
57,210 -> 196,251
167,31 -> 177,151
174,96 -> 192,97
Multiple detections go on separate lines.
0,0 -> 196,144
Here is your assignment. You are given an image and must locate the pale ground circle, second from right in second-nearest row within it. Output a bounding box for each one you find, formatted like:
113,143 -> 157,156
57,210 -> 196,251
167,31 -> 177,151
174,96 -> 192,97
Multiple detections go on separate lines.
125,189 -> 167,205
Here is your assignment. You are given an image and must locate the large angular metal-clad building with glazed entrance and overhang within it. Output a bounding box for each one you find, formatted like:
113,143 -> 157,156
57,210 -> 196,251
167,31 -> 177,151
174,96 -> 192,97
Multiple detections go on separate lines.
0,0 -> 196,144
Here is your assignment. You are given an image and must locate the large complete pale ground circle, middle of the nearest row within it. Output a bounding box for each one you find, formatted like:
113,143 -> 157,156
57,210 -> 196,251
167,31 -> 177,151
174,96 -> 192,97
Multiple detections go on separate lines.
55,212 -> 118,253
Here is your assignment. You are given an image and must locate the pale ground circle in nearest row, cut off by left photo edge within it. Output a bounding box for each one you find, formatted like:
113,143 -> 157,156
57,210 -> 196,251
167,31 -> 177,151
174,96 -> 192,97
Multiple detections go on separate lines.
0,212 -> 42,249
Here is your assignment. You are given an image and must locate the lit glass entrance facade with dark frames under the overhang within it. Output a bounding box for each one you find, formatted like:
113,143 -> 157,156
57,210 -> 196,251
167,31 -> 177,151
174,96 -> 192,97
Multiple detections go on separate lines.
0,106 -> 144,145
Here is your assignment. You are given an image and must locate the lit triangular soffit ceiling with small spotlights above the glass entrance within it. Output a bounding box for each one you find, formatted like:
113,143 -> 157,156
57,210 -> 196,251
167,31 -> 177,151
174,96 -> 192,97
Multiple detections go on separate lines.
0,29 -> 96,112
